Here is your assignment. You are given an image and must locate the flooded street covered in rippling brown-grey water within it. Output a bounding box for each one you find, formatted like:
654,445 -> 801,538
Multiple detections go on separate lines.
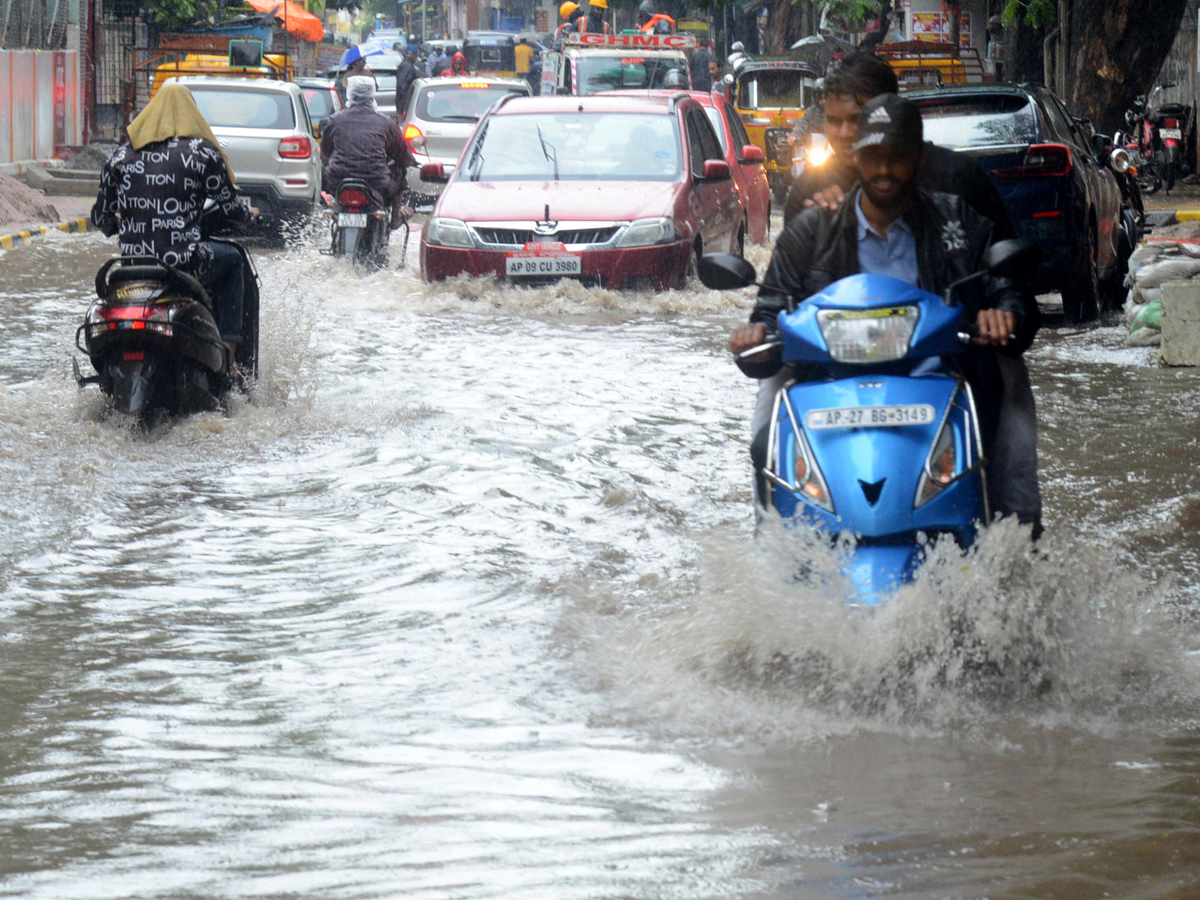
0,222 -> 1200,900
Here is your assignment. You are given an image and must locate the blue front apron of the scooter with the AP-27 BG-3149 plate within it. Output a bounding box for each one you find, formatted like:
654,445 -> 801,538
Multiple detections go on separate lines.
764,372 -> 988,547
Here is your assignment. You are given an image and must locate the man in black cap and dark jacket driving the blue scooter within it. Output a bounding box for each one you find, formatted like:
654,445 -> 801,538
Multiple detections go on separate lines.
730,95 -> 1040,542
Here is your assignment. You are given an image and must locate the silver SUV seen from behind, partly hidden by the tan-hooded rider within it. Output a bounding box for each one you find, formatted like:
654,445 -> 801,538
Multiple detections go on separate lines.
179,76 -> 320,238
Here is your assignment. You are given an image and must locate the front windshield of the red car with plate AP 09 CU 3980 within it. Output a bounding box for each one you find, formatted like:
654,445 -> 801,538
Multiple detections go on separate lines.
458,113 -> 682,181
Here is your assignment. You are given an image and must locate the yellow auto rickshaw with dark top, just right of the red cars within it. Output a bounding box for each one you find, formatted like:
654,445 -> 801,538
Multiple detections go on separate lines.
726,58 -> 820,206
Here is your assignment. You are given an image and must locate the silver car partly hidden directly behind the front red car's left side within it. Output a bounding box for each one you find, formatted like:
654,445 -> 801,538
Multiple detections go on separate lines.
400,76 -> 529,204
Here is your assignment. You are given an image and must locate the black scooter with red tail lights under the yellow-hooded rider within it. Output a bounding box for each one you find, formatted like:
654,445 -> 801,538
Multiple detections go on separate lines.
72,241 -> 258,424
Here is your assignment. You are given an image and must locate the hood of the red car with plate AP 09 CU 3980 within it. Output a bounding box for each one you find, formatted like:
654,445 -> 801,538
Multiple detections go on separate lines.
436,181 -> 684,222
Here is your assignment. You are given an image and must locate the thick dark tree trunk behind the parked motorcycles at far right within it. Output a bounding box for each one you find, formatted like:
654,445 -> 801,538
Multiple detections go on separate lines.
1063,0 -> 1187,134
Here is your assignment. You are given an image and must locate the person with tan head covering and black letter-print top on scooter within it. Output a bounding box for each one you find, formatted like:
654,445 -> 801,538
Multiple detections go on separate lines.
91,80 -> 258,349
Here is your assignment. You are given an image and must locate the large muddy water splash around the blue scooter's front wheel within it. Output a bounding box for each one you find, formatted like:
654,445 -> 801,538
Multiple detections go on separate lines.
562,522 -> 1200,740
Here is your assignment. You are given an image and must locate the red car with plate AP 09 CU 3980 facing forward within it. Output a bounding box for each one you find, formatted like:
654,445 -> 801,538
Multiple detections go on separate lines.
421,91 -> 746,290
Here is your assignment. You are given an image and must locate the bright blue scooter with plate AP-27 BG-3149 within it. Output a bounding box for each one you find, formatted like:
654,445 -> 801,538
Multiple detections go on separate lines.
698,240 -> 1039,604
